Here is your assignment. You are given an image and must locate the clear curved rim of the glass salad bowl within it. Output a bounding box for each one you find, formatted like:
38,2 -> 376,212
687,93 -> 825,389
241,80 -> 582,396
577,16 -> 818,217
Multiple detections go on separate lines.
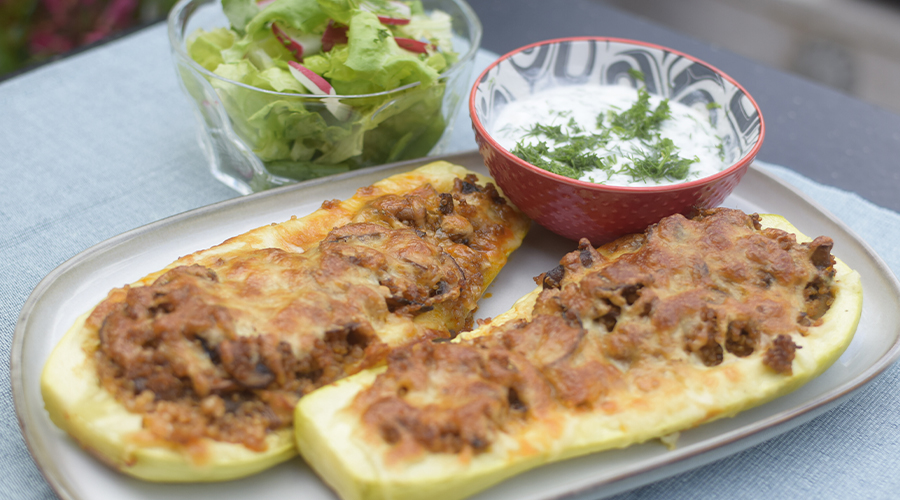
166,0 -> 483,100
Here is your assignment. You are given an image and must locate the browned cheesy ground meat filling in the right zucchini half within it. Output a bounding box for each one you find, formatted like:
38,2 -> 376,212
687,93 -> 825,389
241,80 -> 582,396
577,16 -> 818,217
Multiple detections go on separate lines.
354,209 -> 834,455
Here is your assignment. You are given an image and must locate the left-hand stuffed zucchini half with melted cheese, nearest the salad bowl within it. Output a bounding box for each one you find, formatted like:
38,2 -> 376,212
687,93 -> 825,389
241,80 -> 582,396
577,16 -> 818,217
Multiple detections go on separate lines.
41,162 -> 529,481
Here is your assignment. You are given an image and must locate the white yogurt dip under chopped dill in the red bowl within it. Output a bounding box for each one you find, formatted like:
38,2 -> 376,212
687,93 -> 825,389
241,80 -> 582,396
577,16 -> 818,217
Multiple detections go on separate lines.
491,84 -> 728,186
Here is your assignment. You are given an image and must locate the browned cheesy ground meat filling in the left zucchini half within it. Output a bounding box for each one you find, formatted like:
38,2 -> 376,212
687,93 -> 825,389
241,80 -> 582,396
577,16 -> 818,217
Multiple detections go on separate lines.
87,176 -> 518,451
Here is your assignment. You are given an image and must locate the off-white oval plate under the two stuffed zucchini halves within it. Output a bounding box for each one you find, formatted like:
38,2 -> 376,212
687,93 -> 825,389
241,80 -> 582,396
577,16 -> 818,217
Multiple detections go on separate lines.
10,152 -> 900,500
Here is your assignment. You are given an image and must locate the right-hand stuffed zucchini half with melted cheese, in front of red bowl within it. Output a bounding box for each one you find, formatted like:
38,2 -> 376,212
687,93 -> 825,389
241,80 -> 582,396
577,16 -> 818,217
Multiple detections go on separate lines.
294,209 -> 862,500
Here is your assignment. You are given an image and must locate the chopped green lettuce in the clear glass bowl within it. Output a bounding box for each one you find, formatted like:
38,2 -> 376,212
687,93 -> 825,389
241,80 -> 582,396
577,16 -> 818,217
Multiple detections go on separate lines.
187,0 -> 458,180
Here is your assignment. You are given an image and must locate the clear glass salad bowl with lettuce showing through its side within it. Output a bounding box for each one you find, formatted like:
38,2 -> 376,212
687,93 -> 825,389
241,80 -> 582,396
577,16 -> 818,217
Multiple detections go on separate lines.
168,0 -> 481,194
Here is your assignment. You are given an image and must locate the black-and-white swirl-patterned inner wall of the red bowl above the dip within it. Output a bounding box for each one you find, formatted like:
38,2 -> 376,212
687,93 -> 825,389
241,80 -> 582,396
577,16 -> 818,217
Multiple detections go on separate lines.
472,38 -> 762,173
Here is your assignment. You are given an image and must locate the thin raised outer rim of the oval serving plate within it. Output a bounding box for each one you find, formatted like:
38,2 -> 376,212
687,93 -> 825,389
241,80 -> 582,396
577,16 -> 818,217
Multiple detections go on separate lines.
9,150 -> 900,500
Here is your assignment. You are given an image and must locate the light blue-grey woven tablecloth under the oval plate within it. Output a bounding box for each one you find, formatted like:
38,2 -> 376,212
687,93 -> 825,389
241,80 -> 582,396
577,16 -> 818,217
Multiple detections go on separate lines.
0,20 -> 900,499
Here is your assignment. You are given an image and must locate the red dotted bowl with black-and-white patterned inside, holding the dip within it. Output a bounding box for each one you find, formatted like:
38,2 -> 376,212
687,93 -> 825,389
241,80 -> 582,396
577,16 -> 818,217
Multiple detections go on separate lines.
469,37 -> 765,245
